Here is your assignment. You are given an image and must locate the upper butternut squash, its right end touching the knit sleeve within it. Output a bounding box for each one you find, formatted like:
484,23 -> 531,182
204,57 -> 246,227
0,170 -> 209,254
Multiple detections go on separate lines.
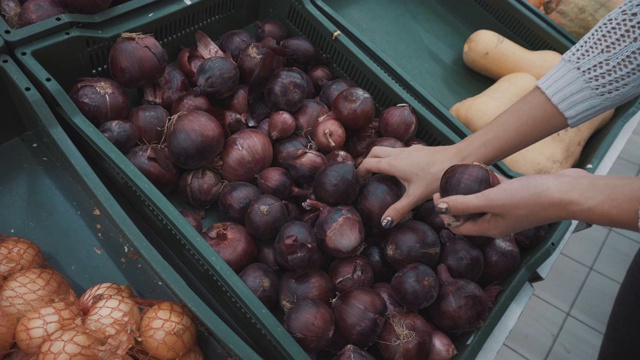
462,29 -> 562,80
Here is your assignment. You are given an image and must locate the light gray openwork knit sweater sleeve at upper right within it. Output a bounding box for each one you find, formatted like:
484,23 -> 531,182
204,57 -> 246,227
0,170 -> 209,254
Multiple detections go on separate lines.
538,0 -> 640,127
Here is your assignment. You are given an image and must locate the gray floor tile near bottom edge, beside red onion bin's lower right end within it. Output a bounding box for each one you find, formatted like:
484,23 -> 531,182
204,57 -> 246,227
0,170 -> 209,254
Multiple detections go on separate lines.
505,295 -> 566,359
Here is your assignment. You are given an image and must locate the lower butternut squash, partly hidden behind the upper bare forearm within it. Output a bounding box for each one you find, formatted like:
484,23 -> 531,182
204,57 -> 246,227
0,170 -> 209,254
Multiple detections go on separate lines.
450,73 -> 614,175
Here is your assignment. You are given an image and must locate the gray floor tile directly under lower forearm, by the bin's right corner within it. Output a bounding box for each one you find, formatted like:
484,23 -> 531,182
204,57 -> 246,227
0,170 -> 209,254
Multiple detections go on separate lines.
562,225 -> 610,267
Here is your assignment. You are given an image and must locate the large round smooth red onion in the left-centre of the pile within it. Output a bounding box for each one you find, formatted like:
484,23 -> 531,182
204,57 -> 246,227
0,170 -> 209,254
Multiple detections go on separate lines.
167,110 -> 225,169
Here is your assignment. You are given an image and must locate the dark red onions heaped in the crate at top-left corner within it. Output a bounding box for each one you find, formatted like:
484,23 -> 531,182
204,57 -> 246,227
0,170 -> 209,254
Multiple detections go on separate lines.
0,0 -> 131,29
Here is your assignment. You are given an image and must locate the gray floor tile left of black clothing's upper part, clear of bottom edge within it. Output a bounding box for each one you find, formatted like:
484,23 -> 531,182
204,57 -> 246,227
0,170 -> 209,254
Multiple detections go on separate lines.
569,271 -> 620,332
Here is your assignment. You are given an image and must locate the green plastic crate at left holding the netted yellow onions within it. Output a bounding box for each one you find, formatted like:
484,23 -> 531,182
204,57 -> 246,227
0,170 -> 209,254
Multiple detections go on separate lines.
0,55 -> 258,359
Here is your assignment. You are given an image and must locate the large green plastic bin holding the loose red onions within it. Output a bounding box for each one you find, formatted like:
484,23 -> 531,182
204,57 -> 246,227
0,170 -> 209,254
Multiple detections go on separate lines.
16,0 -> 570,359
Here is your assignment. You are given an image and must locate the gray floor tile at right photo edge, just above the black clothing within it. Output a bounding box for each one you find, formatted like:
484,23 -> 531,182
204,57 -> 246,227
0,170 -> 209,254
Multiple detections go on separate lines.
593,231 -> 640,282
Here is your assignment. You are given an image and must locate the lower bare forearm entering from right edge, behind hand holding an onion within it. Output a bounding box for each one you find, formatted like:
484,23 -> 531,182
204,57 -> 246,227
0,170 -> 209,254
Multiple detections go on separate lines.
554,173 -> 640,231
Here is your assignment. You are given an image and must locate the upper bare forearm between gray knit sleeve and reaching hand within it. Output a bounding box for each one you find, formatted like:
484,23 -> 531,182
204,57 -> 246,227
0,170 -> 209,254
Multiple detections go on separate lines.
453,87 -> 568,165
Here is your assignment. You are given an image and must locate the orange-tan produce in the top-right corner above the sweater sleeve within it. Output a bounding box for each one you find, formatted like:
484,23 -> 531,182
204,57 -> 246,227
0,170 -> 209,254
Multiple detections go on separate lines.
528,0 -> 624,39
